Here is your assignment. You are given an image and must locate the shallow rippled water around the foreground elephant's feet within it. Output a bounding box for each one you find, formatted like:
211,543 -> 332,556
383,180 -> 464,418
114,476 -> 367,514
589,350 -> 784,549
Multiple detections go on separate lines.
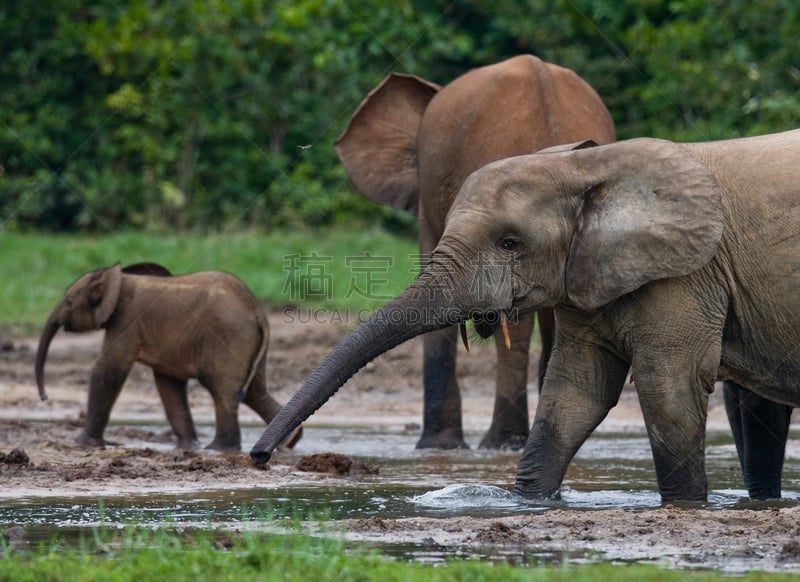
0,427 -> 800,559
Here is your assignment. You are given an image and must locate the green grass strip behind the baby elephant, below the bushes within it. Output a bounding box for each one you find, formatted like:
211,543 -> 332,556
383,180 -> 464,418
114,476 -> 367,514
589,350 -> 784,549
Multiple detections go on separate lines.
0,229 -> 418,331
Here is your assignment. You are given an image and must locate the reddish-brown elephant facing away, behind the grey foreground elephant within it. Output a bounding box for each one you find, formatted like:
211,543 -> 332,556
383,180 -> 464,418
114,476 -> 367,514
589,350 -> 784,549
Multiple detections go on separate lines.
336,55 -> 615,449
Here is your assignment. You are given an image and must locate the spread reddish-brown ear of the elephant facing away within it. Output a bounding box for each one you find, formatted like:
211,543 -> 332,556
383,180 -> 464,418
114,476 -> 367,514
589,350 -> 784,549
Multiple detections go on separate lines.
336,73 -> 441,215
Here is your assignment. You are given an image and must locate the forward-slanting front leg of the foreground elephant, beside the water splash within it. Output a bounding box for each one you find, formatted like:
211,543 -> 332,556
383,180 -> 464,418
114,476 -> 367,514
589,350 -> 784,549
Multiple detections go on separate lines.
514,319 -> 628,499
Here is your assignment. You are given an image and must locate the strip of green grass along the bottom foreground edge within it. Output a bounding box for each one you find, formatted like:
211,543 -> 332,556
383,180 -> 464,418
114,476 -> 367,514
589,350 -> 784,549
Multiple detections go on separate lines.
0,528 -> 794,582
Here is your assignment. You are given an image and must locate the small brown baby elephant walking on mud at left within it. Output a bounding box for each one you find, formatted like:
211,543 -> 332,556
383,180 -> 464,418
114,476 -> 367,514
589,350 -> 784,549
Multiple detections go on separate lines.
35,263 -> 300,451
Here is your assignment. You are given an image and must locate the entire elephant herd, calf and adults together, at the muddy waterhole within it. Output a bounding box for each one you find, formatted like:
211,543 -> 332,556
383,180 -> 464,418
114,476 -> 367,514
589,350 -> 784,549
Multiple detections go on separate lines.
36,55 -> 800,501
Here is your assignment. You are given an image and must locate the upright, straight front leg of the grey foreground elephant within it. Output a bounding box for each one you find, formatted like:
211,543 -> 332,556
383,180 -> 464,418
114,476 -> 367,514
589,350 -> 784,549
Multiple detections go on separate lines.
618,280 -> 727,501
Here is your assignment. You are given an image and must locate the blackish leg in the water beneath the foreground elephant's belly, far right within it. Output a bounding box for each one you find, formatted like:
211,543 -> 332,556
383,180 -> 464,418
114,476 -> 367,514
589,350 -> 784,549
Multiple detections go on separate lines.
724,382 -> 792,499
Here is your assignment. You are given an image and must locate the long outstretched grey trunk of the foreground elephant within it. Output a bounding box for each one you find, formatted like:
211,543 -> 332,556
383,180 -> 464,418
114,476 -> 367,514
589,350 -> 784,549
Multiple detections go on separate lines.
250,277 -> 465,464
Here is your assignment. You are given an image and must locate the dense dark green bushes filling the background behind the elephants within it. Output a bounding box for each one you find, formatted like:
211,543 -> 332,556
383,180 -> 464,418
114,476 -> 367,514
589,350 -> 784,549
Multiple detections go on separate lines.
0,0 -> 800,231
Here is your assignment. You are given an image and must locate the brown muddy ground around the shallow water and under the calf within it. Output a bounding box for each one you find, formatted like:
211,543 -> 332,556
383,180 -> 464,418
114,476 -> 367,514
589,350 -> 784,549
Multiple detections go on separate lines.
0,310 -> 800,571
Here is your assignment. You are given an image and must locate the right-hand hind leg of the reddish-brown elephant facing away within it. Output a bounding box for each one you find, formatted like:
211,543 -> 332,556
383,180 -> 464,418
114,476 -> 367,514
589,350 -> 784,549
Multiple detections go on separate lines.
480,313 -> 534,451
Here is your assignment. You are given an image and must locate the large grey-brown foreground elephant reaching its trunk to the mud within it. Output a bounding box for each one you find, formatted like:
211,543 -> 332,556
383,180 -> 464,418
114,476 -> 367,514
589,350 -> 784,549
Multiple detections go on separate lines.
250,130 -> 800,502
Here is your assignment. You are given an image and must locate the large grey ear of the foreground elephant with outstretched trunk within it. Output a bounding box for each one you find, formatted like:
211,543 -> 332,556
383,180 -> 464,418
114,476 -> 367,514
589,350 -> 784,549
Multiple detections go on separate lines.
566,138 -> 723,308
